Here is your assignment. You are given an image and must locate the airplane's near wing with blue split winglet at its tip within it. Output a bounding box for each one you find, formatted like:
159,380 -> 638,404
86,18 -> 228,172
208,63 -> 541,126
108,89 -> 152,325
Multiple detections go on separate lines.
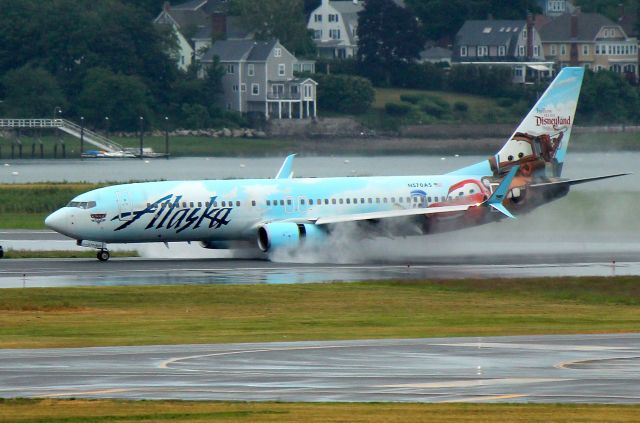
306,166 -> 519,225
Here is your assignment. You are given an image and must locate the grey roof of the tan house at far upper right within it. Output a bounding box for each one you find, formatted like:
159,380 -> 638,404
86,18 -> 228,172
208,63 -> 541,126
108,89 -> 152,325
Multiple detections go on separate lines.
540,13 -> 617,42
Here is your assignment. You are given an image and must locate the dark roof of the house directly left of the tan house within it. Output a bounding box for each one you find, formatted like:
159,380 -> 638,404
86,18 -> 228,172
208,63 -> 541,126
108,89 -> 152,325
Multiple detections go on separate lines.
456,20 -> 526,46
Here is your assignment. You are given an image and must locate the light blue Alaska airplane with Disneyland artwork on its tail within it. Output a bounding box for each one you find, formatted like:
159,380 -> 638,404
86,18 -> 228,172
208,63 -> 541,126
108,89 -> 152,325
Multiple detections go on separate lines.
45,67 -> 624,261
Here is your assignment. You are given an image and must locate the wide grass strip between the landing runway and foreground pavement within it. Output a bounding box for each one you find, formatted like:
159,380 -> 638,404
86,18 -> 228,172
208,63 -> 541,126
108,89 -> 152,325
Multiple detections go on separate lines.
0,277 -> 640,348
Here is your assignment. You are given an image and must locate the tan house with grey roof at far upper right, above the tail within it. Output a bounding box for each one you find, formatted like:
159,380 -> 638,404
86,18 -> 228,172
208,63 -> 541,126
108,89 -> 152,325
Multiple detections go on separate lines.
540,10 -> 638,80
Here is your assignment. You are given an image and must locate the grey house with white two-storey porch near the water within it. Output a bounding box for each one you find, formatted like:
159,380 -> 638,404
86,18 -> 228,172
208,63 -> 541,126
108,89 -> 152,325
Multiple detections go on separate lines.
202,39 -> 318,119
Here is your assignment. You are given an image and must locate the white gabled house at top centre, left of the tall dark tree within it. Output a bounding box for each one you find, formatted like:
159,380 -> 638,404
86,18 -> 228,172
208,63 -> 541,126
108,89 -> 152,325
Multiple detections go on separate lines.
307,0 -> 406,59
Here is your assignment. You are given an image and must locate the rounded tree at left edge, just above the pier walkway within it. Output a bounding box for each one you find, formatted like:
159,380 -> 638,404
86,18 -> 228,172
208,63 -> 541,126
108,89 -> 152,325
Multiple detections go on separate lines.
1,65 -> 67,118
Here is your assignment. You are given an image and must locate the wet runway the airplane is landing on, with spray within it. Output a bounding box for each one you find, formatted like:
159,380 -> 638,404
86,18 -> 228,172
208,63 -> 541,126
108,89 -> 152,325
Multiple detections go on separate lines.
0,228 -> 640,288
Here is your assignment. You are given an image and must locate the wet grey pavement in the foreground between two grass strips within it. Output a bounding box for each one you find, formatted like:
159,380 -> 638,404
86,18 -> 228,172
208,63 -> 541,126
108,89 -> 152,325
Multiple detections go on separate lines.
0,334 -> 640,403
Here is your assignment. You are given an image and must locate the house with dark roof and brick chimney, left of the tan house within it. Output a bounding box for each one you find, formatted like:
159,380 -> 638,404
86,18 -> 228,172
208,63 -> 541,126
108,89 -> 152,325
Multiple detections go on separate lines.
452,17 -> 553,83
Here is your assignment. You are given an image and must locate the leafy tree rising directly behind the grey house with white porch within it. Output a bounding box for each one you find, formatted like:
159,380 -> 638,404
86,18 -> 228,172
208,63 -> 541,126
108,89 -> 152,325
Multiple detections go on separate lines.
230,0 -> 315,55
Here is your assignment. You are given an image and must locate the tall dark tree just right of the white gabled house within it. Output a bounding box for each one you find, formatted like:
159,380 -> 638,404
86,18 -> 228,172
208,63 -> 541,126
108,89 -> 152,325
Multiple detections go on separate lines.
357,0 -> 424,85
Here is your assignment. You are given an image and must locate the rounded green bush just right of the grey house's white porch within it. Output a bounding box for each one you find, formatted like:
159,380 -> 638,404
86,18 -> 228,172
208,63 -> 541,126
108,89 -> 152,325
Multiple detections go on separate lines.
315,75 -> 375,114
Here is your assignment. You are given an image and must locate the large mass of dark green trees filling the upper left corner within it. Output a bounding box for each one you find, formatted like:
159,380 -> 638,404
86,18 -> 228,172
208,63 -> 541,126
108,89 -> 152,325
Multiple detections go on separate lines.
0,0 -> 230,130
